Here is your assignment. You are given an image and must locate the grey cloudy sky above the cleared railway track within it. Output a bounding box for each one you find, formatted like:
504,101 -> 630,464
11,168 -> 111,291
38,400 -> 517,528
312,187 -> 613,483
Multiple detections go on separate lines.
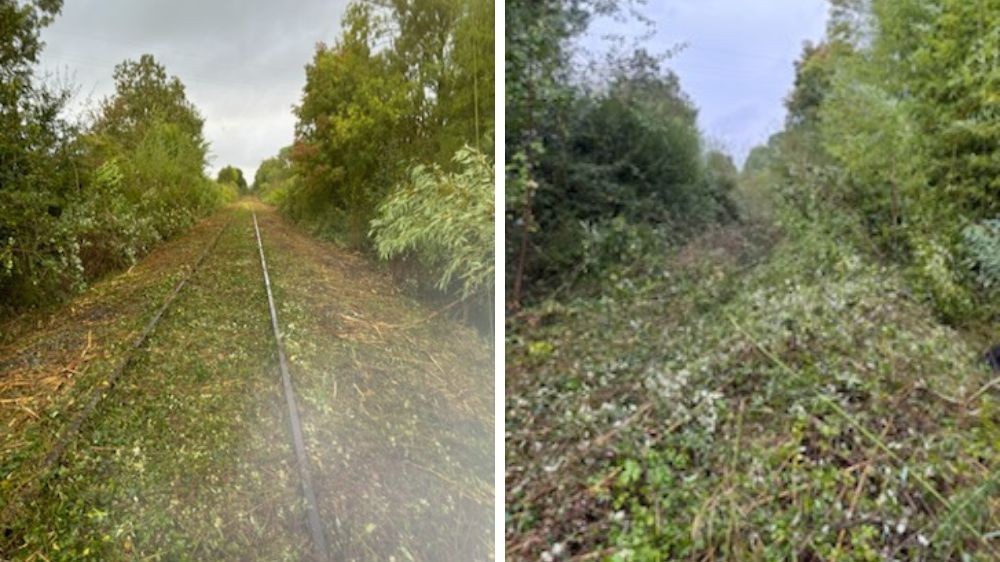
40,0 -> 347,181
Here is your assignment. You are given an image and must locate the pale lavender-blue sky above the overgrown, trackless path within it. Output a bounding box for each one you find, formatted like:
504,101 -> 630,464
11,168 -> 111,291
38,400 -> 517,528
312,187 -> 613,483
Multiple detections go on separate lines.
585,0 -> 828,164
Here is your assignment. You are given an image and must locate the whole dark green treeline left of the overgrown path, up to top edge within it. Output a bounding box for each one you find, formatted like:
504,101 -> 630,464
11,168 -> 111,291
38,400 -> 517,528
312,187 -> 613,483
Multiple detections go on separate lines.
505,0 -> 737,308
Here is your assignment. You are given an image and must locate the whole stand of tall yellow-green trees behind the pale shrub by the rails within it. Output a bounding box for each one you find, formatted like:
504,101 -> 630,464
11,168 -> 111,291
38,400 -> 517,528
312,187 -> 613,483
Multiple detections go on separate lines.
285,0 -> 493,248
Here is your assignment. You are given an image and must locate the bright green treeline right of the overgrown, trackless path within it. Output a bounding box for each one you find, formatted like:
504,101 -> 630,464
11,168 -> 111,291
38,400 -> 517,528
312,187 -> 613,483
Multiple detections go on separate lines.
744,0 -> 1000,323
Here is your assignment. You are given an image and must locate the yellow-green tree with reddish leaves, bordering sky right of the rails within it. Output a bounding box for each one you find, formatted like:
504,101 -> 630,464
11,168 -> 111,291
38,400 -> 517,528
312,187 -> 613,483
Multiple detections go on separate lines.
288,3 -> 415,247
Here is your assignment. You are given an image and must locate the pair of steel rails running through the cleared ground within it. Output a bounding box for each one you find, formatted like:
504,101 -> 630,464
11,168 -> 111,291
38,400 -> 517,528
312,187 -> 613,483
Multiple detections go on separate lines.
0,211 -> 331,562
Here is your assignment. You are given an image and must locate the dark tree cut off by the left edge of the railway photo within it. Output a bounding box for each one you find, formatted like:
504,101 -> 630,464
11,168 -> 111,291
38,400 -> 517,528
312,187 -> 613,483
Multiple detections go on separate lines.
0,0 -> 81,304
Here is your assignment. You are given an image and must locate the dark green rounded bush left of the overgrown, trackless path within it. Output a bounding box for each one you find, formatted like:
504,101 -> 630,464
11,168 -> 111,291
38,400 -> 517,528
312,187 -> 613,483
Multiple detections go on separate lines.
507,51 -> 737,301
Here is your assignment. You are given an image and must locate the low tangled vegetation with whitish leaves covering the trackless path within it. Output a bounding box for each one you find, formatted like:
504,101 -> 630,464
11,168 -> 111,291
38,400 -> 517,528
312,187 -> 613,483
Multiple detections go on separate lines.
506,219 -> 1000,561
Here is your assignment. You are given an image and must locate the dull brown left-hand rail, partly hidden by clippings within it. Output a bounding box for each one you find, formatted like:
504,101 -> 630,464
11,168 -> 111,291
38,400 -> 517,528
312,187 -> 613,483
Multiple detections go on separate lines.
0,217 -> 232,522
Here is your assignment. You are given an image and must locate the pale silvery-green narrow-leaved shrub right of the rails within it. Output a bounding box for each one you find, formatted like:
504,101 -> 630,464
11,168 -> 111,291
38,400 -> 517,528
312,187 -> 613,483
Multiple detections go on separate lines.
372,147 -> 494,298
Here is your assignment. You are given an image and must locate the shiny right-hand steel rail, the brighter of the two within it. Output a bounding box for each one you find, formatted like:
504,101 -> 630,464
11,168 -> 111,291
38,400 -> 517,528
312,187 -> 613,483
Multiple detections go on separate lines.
251,210 -> 330,562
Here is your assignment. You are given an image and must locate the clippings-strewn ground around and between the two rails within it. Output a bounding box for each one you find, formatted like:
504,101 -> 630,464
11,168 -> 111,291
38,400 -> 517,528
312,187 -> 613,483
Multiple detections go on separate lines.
0,203 -> 492,560
